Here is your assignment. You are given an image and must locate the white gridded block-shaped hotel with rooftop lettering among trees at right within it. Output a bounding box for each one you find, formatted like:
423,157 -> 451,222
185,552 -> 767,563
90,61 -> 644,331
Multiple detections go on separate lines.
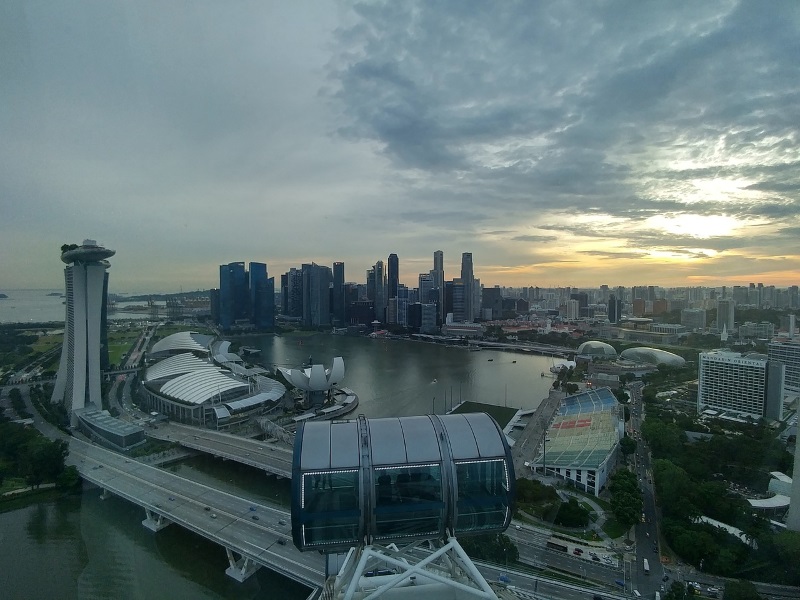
697,350 -> 785,421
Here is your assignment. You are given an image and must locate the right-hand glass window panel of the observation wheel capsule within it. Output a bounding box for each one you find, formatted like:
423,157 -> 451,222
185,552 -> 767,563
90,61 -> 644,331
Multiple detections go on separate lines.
455,459 -> 510,533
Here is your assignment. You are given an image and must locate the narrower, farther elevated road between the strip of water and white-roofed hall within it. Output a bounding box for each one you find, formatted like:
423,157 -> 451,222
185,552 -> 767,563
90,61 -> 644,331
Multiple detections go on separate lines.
146,423 -> 292,479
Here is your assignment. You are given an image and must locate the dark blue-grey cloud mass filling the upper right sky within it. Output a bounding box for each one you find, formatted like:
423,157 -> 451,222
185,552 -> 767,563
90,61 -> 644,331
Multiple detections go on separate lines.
336,2 -> 800,233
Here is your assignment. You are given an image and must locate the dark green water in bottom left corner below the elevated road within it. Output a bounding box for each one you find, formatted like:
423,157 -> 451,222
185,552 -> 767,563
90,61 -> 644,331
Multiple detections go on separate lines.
0,487 -> 308,600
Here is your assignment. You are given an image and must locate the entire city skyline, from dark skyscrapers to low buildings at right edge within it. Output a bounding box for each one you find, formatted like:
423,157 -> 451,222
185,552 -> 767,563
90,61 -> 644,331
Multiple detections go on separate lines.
206,250 -> 800,342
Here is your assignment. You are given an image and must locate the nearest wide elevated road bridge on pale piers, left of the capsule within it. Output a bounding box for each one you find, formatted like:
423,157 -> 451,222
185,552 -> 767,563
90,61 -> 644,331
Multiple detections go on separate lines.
68,438 -> 325,588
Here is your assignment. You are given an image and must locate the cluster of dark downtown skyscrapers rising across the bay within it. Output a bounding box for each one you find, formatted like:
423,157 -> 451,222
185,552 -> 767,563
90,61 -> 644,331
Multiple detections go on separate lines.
211,250 -> 478,333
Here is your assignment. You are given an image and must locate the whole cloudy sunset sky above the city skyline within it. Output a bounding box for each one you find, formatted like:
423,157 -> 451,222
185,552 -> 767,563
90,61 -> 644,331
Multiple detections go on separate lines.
0,0 -> 800,293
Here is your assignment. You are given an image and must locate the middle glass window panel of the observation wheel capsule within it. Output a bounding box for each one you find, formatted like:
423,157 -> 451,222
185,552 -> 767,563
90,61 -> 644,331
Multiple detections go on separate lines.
373,464 -> 444,539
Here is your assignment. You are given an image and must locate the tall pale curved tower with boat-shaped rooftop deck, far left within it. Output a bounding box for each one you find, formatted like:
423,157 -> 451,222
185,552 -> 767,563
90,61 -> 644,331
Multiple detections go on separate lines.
51,240 -> 116,425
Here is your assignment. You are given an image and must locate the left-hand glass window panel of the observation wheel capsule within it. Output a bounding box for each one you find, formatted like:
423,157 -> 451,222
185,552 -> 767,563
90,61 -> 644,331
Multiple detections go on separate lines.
301,469 -> 361,546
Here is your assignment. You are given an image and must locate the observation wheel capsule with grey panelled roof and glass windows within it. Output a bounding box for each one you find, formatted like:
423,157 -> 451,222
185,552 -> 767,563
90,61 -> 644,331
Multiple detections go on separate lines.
292,413 -> 515,552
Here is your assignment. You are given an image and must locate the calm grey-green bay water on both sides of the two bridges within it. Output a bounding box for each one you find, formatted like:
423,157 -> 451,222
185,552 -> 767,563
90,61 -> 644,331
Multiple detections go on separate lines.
0,335 -> 553,600
